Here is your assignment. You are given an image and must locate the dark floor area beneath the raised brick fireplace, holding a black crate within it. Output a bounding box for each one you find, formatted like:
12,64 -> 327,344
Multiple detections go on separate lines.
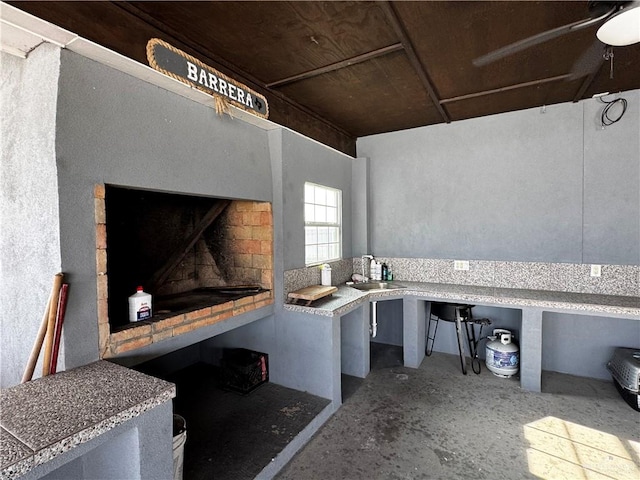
169,363 -> 330,480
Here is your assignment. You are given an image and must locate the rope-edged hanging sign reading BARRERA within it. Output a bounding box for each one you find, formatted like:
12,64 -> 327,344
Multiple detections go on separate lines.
147,38 -> 269,118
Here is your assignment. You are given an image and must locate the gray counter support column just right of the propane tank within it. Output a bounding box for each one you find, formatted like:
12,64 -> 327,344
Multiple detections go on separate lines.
520,308 -> 542,392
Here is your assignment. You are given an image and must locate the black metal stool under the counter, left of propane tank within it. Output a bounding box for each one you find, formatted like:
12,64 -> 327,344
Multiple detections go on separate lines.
424,302 -> 491,375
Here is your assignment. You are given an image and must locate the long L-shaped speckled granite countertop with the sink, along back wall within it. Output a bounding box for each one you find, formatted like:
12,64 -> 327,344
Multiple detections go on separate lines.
285,281 -> 640,320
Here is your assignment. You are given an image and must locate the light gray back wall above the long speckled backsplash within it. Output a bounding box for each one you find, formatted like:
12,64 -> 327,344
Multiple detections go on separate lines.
357,90 -> 640,265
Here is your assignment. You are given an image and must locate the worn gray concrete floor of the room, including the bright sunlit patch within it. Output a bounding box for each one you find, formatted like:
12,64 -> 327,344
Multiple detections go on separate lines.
276,344 -> 640,480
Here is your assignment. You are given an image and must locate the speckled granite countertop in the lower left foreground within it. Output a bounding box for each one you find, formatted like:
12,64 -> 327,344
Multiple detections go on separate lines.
0,361 -> 176,479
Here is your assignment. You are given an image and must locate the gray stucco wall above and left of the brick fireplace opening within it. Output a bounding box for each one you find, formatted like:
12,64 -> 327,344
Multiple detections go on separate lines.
56,51 -> 272,368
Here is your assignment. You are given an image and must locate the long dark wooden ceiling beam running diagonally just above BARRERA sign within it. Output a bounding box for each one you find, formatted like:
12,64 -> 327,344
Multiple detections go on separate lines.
111,2 -> 354,138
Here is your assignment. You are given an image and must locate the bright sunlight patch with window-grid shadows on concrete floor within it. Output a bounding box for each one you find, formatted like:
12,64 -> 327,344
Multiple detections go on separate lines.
524,417 -> 640,480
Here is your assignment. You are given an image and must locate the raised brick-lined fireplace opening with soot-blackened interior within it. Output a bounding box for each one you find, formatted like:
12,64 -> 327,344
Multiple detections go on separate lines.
95,185 -> 273,358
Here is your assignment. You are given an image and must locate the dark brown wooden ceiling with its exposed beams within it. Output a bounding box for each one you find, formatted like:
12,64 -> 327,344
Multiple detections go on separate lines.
8,1 -> 640,155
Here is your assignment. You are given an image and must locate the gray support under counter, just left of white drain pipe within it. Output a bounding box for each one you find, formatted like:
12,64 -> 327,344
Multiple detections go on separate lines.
340,302 -> 371,378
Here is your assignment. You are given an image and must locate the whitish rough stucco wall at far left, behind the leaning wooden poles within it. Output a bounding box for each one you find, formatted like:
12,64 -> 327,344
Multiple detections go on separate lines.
0,44 -> 64,388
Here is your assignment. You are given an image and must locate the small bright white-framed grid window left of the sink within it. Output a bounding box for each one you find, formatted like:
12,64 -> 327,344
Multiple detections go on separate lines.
304,182 -> 342,265
